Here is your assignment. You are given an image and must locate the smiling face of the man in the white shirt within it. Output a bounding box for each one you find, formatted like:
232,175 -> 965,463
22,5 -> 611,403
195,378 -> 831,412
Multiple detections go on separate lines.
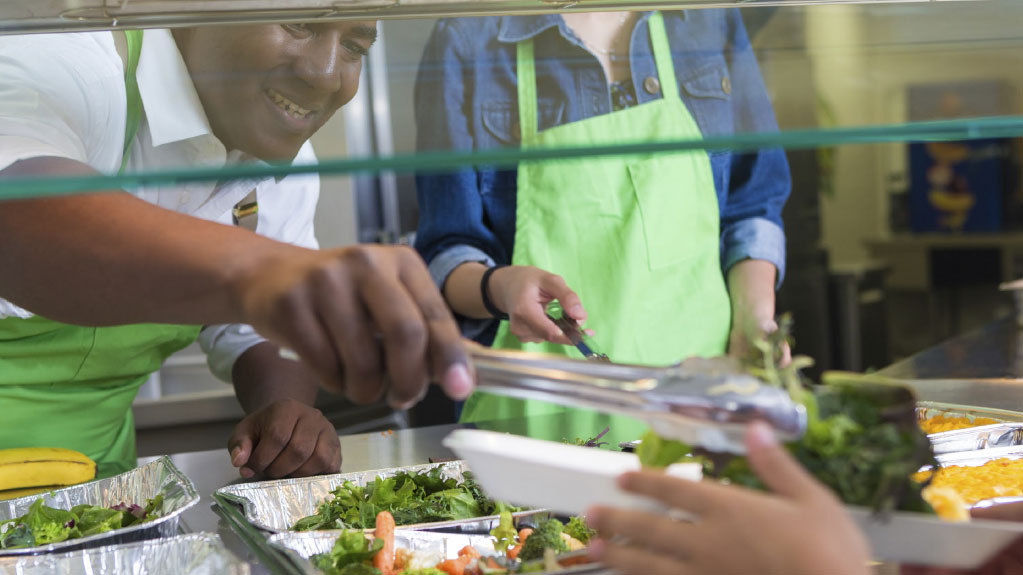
174,21 -> 376,161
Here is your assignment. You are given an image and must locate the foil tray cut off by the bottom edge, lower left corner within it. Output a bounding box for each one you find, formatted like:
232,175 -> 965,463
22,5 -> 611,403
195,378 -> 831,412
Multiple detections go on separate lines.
0,533 -> 249,575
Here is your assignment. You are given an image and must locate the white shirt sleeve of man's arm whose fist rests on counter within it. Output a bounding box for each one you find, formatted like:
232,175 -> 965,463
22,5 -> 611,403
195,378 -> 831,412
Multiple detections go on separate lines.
198,142 -> 319,383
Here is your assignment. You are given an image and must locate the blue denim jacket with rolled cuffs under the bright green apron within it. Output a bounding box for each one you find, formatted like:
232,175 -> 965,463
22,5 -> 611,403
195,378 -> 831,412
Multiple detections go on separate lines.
415,10 -> 790,344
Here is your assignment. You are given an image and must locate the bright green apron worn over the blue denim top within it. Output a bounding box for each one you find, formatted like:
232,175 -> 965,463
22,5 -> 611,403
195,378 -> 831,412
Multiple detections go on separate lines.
461,12 -> 731,440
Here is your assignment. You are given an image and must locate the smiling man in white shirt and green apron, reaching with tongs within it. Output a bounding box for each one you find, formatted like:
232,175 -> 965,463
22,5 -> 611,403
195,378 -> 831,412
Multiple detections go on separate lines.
0,23 -> 472,477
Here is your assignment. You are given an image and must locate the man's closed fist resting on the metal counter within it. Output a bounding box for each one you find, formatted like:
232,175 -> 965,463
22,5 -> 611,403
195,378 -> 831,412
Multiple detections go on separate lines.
227,399 -> 341,479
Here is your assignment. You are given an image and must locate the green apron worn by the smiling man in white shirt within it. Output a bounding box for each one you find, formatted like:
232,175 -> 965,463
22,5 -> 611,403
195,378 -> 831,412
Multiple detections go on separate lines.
0,31 -> 199,477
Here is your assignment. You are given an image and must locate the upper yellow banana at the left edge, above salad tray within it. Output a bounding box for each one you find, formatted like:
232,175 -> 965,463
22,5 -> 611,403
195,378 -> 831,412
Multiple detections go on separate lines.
0,447 -> 96,491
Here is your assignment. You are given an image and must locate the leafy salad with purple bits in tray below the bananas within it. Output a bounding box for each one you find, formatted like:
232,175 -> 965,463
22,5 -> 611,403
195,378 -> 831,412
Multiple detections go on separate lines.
0,495 -> 164,549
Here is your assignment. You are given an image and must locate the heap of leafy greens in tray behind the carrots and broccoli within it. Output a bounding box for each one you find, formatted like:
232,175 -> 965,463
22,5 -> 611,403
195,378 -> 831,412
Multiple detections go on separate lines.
292,466 -> 520,531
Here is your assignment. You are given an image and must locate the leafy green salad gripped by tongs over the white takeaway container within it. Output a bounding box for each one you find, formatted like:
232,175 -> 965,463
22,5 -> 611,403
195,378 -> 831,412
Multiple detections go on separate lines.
636,318 -> 934,513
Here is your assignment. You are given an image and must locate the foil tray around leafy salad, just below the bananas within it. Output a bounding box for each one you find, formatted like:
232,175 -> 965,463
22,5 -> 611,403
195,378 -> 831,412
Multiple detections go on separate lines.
0,456 -> 198,558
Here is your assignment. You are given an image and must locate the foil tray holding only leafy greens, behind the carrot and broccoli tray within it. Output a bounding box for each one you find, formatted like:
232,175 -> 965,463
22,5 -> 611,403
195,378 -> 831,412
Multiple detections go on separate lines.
217,461 -> 545,533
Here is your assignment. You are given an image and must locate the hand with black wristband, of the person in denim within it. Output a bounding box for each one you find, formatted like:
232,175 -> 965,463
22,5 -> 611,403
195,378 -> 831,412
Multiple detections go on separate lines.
489,266 -> 586,346
